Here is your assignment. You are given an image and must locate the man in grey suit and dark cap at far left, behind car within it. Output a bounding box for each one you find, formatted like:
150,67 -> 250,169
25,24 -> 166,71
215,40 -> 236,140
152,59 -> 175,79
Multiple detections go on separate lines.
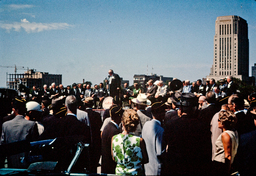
0,98 -> 39,168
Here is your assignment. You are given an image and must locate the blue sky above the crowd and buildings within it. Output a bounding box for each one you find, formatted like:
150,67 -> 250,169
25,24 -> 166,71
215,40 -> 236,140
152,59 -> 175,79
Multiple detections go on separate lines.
0,0 -> 256,87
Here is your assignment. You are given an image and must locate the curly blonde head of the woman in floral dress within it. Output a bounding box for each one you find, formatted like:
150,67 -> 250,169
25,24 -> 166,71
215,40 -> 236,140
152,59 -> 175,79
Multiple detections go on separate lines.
122,109 -> 139,132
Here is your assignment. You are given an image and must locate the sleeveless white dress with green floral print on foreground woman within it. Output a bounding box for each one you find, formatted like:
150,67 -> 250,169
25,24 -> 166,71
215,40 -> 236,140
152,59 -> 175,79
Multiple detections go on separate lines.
112,134 -> 144,175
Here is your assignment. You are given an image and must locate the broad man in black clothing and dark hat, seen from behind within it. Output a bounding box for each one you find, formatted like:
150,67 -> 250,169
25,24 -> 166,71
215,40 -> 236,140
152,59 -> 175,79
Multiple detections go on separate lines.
162,93 -> 211,175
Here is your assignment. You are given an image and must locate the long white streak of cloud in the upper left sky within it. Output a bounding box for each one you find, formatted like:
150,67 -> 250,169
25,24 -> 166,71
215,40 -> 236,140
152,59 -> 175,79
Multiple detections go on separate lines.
0,19 -> 72,33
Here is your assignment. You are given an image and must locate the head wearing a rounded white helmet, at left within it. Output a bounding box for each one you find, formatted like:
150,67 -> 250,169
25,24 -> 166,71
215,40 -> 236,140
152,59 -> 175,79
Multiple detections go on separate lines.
26,101 -> 42,121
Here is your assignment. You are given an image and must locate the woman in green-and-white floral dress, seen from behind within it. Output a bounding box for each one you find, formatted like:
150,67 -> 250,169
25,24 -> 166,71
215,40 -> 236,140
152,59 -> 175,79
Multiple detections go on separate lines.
111,109 -> 148,175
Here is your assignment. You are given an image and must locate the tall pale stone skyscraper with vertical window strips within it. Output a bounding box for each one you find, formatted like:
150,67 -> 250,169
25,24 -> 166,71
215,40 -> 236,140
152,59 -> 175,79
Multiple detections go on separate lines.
207,16 -> 249,80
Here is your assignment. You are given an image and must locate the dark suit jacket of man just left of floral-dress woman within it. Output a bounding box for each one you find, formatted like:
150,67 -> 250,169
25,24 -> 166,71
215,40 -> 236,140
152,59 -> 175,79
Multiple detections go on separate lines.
101,122 -> 121,174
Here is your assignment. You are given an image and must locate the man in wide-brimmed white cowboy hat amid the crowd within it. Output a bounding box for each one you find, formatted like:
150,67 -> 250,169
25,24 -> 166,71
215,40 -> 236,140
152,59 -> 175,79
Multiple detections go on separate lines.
132,93 -> 152,136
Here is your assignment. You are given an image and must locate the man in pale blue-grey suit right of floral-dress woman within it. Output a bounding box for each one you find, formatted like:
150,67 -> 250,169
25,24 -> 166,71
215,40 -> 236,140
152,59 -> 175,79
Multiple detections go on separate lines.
142,102 -> 165,175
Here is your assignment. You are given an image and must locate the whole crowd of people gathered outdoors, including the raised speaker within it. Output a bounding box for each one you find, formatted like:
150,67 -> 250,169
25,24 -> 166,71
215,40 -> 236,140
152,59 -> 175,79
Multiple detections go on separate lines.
1,70 -> 256,175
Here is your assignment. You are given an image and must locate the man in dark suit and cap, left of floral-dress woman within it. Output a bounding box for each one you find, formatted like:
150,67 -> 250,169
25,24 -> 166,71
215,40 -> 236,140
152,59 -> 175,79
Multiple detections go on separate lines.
101,105 -> 123,174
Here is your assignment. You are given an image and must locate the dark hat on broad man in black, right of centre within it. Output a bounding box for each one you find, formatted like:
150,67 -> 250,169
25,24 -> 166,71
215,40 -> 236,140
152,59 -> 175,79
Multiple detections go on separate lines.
175,93 -> 197,107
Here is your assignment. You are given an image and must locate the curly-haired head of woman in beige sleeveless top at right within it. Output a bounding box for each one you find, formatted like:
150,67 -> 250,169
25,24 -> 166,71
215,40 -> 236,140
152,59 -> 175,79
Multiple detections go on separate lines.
218,111 -> 237,130
